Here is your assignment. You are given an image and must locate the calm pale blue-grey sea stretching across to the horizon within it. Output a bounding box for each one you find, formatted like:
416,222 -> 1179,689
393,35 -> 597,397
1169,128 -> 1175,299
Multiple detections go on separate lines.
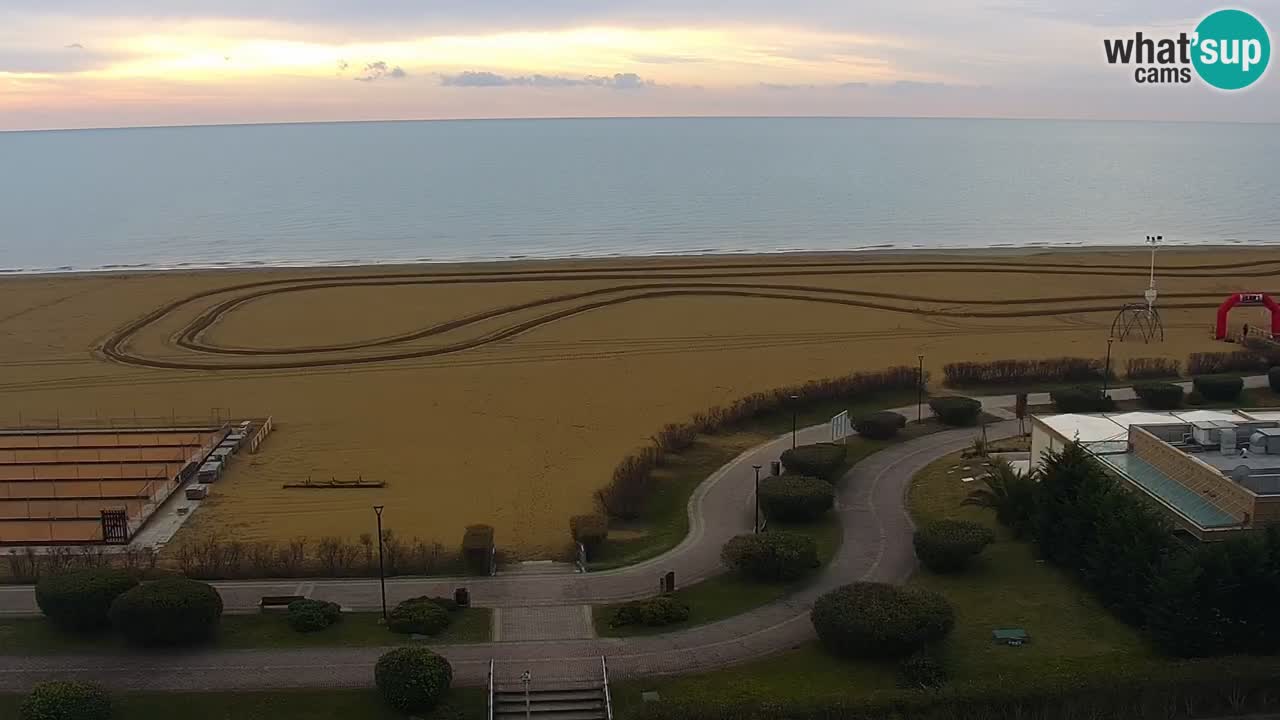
0,118 -> 1280,273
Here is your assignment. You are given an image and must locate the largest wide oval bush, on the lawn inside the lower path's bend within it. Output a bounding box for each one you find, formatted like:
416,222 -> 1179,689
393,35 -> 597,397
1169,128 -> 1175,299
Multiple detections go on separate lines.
809,583 -> 955,657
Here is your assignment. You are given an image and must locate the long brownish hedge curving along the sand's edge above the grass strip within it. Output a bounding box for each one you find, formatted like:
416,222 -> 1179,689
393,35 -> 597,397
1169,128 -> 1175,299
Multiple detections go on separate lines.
595,366 -> 928,520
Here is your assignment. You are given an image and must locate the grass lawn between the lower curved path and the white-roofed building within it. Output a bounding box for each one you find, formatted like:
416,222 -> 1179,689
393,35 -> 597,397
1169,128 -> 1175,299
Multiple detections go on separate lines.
613,454 -> 1162,714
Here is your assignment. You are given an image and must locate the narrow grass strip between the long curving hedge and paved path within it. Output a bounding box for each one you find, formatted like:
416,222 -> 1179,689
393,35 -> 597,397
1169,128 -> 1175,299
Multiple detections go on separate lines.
591,392 -> 915,570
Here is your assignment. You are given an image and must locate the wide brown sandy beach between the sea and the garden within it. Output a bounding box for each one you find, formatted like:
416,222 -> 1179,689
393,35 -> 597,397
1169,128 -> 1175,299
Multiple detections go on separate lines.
0,249 -> 1280,557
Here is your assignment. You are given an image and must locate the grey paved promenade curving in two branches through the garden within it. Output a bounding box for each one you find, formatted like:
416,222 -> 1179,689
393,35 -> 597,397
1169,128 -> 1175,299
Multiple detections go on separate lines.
0,421 -> 1016,691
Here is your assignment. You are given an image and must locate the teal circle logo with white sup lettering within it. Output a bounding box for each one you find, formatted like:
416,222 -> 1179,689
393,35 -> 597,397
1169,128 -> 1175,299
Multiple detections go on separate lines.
1192,10 -> 1271,90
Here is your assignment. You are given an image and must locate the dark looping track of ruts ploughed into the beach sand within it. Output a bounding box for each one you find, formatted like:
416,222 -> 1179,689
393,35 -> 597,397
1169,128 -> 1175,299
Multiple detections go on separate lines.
97,254 -> 1280,370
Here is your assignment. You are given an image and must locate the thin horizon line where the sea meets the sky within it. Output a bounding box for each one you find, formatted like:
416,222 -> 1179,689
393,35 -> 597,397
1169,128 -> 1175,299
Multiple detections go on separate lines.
0,115 -> 1280,135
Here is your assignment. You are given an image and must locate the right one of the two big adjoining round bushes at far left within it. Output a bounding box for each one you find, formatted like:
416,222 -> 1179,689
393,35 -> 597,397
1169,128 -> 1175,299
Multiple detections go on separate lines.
111,578 -> 223,646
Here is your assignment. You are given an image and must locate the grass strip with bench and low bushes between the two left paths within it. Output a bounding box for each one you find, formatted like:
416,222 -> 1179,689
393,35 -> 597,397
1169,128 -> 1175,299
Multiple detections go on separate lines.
0,607 -> 492,655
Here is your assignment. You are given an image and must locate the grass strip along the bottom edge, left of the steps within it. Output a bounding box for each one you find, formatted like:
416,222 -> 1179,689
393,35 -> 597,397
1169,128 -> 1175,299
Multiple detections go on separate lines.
0,688 -> 486,720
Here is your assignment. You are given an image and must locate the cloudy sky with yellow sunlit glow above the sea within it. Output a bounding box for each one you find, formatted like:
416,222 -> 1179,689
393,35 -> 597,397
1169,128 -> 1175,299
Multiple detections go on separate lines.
0,0 -> 1280,129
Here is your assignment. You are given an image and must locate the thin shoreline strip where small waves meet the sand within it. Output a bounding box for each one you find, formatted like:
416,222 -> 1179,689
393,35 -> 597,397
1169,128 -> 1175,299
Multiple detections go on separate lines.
0,240 -> 1264,281
